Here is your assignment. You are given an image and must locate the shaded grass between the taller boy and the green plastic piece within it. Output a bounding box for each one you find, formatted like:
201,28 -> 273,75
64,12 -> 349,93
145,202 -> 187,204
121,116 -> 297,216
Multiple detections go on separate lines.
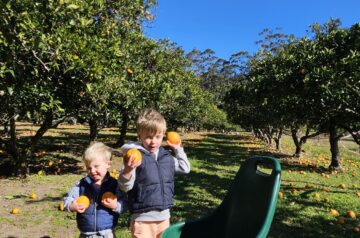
172,134 -> 272,221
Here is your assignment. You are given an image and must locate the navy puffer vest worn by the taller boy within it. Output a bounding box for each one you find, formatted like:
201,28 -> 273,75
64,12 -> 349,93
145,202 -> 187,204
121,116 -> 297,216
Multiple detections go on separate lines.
128,147 -> 175,213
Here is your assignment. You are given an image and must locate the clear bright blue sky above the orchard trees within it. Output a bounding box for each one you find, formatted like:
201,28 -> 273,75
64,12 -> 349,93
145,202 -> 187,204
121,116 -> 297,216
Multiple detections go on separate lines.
145,0 -> 360,59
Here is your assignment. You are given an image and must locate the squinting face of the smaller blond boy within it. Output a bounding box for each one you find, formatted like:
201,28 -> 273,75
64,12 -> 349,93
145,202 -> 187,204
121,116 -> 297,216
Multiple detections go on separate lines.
86,156 -> 110,184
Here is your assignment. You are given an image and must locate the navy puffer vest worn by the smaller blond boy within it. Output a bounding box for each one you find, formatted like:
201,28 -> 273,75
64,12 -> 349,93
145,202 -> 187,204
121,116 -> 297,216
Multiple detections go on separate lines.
76,173 -> 119,232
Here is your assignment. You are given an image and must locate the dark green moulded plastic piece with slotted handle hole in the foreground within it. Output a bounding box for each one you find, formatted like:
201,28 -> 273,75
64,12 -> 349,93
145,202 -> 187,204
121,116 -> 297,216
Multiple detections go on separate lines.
162,156 -> 281,238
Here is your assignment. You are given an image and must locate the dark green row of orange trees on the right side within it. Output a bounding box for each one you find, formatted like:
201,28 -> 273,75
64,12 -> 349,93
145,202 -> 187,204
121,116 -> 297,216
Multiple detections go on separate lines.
227,20 -> 360,169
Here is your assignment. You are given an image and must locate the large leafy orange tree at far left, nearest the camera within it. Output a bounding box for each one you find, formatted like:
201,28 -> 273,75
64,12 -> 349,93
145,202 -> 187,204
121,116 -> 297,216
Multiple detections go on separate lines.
0,0 -> 155,173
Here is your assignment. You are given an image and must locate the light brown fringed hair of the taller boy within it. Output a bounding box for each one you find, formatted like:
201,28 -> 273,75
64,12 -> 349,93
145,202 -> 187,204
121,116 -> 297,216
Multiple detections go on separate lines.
136,108 -> 166,135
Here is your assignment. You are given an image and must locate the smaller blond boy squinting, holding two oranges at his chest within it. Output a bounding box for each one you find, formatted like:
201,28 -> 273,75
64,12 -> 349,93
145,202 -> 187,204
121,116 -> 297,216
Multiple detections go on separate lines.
64,142 -> 127,238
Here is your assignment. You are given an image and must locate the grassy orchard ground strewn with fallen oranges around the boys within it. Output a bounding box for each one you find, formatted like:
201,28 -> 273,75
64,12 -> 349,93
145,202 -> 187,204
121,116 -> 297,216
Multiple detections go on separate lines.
0,123 -> 360,238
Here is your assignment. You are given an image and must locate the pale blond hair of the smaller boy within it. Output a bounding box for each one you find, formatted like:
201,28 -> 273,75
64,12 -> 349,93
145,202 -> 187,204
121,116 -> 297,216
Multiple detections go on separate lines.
83,142 -> 112,164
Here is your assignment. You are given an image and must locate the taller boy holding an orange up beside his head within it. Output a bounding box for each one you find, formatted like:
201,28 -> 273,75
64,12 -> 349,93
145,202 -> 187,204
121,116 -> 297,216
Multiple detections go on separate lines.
119,109 -> 190,238
